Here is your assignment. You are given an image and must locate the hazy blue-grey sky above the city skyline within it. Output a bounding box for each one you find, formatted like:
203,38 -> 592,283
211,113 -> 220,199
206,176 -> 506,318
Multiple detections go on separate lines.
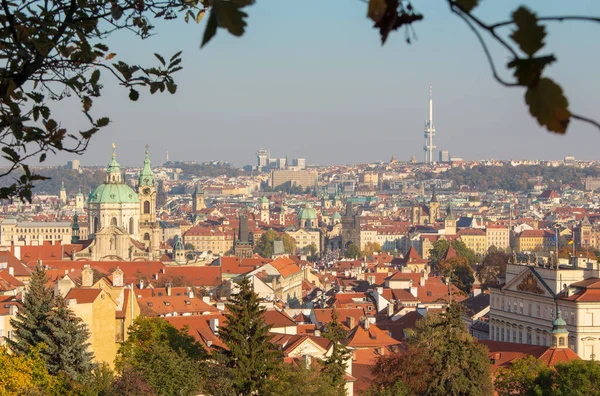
49,0 -> 600,166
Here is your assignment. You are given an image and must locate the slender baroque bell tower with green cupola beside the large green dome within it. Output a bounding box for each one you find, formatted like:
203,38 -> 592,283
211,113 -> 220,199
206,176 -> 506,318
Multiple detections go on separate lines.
138,145 -> 160,258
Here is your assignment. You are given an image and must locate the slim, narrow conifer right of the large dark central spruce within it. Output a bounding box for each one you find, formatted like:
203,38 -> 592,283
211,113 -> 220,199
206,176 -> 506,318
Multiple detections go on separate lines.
323,308 -> 350,392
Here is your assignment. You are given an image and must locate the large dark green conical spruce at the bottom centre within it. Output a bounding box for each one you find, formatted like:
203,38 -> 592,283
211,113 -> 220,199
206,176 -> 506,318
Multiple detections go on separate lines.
220,277 -> 280,395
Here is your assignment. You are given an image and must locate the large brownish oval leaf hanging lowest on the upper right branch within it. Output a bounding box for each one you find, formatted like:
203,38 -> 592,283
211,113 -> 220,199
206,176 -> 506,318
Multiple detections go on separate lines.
525,78 -> 571,133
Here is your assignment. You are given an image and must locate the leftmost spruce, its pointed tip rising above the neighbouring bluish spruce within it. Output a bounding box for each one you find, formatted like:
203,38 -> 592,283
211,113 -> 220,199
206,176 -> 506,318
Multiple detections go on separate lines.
7,264 -> 53,355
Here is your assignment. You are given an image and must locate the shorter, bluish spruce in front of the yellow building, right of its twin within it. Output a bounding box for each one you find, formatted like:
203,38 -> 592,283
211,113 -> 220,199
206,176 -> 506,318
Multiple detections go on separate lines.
41,295 -> 94,380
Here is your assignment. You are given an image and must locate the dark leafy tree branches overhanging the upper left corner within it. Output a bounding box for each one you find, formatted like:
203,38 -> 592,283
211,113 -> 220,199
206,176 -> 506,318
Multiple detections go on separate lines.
0,0 -> 209,200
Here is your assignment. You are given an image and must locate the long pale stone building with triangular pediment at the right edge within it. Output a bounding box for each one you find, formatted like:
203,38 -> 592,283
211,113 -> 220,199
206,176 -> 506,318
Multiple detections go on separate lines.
489,263 -> 600,359
